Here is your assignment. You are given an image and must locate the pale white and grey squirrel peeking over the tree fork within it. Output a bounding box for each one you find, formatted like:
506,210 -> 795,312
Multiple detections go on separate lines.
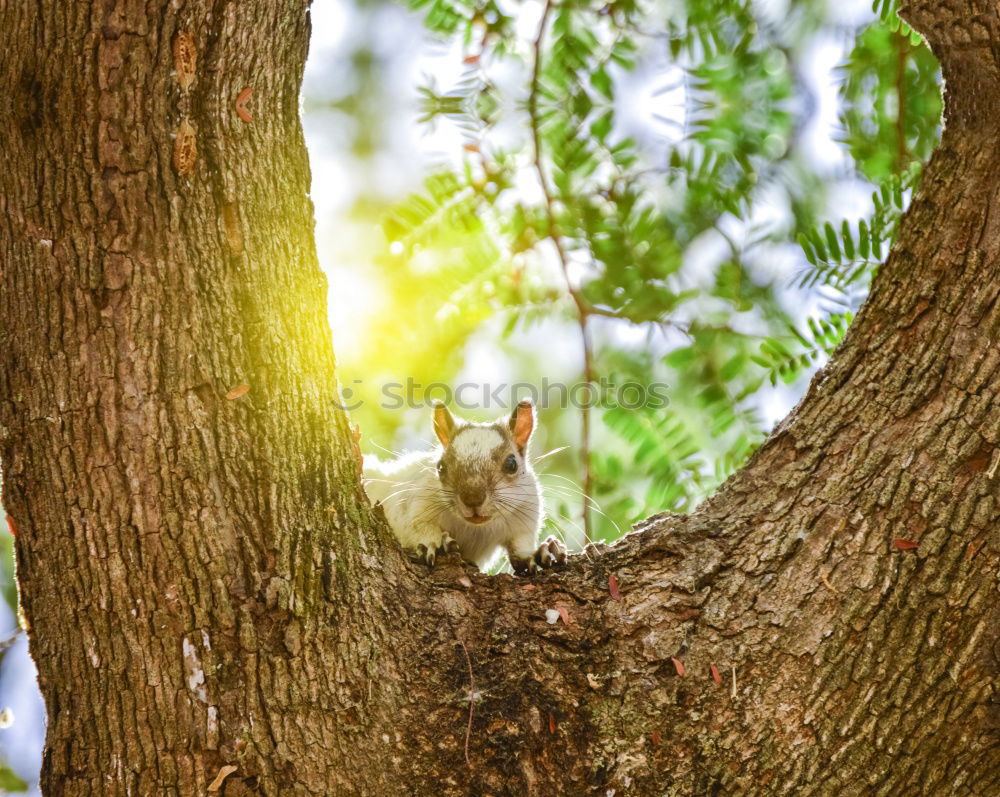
363,400 -> 566,575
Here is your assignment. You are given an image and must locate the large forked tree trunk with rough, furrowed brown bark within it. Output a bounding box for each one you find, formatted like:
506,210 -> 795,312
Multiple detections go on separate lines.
0,0 -> 1000,795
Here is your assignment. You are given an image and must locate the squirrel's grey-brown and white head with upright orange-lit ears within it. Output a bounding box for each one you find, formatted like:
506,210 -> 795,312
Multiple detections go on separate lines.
434,401 -> 536,525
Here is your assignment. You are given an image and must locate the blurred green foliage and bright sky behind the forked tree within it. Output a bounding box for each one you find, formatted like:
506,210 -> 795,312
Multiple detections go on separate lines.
0,0 -> 941,792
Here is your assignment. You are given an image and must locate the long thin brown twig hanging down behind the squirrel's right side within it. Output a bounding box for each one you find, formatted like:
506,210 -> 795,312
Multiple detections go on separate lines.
528,0 -> 594,539
